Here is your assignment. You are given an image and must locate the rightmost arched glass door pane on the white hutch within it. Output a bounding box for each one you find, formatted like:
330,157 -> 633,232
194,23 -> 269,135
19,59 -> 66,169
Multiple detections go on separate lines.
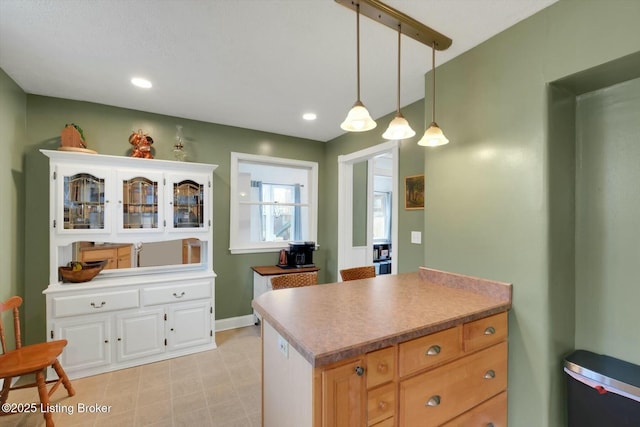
172,179 -> 207,229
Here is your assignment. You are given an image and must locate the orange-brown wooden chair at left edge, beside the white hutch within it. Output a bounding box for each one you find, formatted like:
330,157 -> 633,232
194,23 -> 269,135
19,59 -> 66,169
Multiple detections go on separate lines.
0,296 -> 76,427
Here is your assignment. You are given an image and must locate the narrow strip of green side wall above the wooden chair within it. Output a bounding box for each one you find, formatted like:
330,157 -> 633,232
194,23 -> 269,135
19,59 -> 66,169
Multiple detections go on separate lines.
0,69 -> 27,348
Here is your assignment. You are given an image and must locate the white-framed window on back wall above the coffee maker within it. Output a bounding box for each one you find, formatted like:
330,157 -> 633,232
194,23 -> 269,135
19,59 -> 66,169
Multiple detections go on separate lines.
229,153 -> 318,254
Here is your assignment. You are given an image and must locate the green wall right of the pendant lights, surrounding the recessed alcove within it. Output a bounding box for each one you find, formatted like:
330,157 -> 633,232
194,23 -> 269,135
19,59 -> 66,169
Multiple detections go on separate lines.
424,0 -> 640,426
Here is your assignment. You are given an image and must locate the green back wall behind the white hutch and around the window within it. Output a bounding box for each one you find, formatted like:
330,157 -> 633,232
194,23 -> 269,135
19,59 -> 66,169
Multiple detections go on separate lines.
25,95 -> 324,341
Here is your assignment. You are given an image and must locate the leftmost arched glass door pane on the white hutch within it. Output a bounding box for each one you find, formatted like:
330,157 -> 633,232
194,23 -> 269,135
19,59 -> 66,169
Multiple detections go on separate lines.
58,171 -> 108,232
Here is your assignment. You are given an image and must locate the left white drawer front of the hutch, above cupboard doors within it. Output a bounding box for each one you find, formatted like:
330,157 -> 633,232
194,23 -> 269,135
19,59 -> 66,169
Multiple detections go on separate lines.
53,290 -> 140,317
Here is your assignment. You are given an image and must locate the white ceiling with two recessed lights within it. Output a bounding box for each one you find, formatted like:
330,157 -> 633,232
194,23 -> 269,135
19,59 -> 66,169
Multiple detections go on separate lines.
0,0 -> 556,141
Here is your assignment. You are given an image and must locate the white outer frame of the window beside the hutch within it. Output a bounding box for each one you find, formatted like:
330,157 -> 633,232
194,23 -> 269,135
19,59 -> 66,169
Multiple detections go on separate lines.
229,152 -> 318,254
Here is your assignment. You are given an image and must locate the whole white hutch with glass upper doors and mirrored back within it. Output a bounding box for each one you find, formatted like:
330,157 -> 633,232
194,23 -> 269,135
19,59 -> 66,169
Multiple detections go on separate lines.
41,150 -> 217,378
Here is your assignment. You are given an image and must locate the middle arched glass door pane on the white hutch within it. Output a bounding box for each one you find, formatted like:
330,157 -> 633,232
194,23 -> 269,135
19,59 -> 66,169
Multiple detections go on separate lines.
121,176 -> 161,230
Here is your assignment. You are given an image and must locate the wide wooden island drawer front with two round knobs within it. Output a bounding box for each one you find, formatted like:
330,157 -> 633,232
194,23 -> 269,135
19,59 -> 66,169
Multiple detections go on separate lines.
399,342 -> 507,427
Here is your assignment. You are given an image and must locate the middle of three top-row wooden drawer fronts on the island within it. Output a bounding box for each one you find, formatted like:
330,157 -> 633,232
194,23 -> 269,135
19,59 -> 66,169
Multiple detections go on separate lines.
399,326 -> 462,377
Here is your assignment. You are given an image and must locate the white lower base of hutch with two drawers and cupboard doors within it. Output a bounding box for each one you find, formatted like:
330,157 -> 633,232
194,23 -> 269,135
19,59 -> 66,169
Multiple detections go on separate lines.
45,272 -> 216,378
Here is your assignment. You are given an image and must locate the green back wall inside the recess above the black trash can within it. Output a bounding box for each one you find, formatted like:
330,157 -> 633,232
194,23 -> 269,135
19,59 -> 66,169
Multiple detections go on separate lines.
576,78 -> 640,365
